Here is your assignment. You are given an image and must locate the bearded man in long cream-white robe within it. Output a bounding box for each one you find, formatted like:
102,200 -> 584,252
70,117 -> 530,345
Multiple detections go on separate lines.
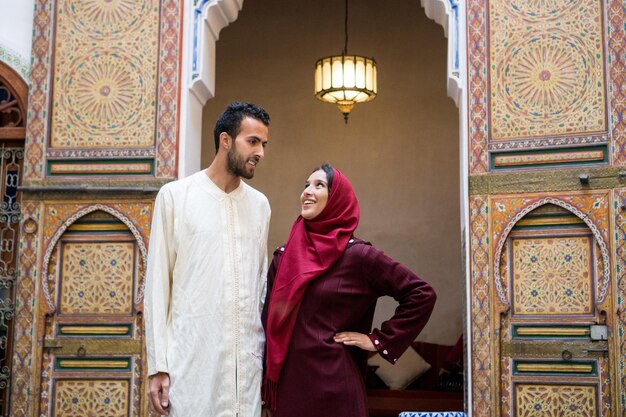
145,103 -> 270,417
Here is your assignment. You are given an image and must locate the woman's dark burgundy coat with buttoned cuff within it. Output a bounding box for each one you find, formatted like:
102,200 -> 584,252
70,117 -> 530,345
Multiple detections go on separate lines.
263,239 -> 436,417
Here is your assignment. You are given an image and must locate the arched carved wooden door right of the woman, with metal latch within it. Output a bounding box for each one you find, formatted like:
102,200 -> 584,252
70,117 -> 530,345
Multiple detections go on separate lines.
500,204 -> 612,417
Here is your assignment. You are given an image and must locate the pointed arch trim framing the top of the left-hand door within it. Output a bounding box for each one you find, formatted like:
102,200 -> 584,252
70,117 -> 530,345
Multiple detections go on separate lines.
41,204 -> 148,314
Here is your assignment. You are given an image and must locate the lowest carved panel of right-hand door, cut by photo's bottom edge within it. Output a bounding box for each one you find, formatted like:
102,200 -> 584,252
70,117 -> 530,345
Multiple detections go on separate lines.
515,384 -> 597,417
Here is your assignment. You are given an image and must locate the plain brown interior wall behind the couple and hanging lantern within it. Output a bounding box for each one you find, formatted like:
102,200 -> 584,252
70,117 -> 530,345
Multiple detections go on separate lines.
202,0 -> 464,344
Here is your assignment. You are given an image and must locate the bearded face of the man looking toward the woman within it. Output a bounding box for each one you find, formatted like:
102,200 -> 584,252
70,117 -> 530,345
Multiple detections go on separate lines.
227,117 -> 269,179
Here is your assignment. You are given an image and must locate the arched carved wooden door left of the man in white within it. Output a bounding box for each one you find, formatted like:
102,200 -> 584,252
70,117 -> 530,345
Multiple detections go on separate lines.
39,211 -> 147,417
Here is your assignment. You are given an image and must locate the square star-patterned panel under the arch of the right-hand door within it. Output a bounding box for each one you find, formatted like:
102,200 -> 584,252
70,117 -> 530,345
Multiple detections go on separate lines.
511,236 -> 594,315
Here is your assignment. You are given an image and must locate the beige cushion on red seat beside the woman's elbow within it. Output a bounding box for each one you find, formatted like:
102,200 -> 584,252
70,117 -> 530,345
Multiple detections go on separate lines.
367,348 -> 430,390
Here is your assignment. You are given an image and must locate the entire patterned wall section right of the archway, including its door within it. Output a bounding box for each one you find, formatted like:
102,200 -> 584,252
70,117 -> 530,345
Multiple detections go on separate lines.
466,0 -> 626,417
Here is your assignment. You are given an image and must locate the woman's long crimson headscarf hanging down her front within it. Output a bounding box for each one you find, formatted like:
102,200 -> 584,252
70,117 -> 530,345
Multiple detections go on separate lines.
263,168 -> 360,409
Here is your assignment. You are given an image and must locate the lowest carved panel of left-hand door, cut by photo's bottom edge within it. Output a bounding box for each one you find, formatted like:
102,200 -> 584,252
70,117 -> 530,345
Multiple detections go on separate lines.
54,380 -> 130,417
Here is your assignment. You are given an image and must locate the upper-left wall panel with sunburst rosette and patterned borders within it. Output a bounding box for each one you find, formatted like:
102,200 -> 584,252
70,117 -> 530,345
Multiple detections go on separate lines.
24,0 -> 182,179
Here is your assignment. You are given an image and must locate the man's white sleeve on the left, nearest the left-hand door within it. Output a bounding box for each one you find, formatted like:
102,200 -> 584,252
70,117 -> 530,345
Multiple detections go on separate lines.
144,189 -> 176,375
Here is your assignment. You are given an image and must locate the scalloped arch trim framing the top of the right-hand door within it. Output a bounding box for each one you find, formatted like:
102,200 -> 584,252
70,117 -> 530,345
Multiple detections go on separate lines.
493,197 -> 611,306
